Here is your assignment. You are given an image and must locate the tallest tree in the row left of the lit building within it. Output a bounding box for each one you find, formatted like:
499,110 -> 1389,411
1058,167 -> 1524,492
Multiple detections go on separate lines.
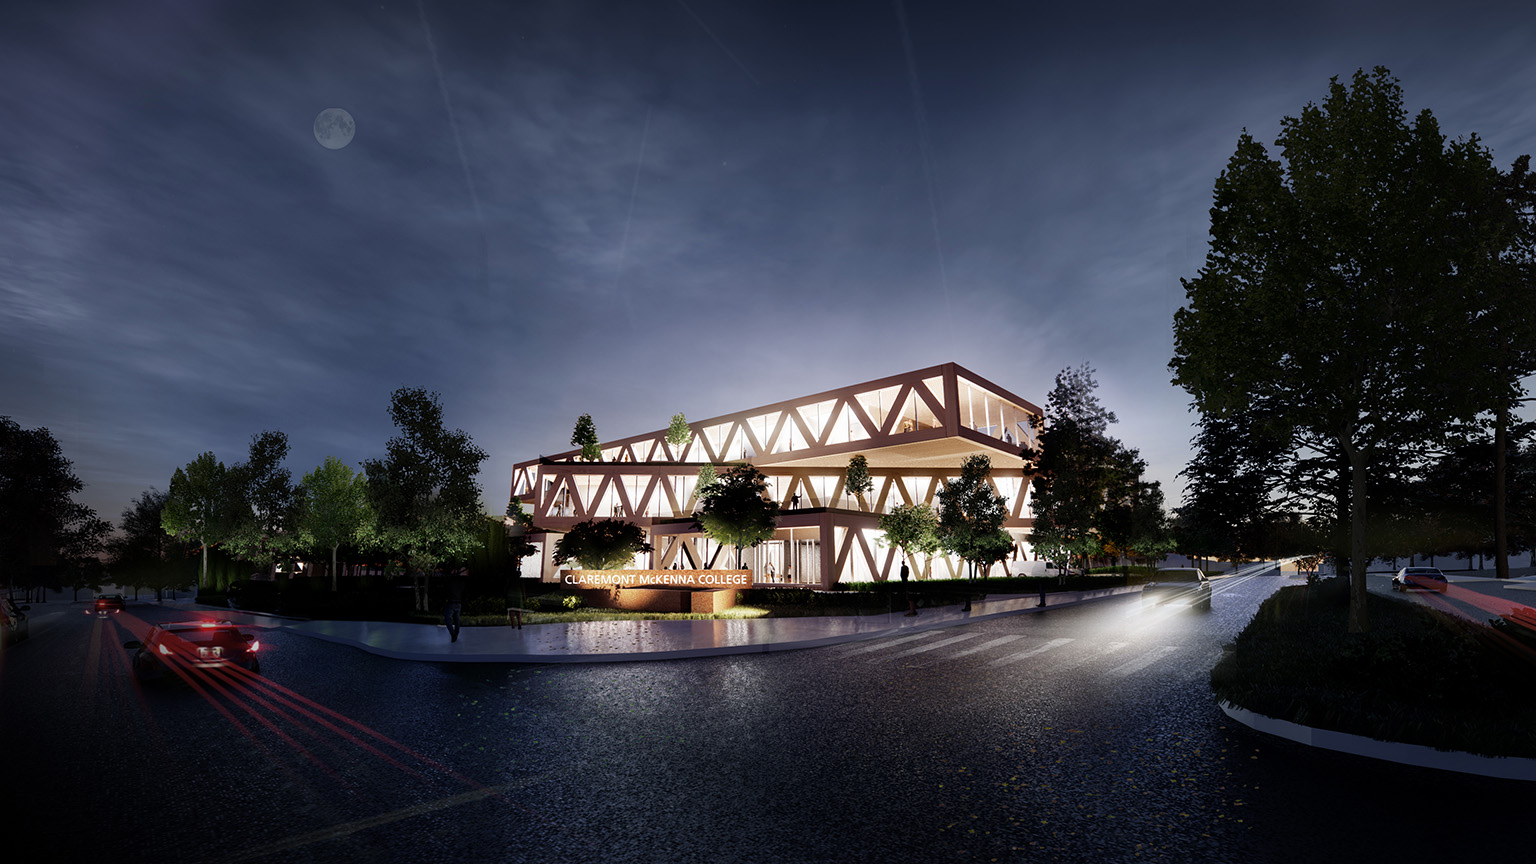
362,387 -> 488,612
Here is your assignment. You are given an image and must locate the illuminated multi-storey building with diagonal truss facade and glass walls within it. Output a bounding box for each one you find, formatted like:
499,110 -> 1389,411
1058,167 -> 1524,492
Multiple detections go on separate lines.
511,363 -> 1040,587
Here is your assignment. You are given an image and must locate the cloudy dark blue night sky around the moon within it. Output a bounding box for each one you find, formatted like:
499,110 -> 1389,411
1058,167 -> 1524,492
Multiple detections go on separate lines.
0,0 -> 1536,521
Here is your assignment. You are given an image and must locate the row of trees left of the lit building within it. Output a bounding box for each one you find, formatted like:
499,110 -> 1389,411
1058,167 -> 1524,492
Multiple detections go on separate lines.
145,387 -> 531,610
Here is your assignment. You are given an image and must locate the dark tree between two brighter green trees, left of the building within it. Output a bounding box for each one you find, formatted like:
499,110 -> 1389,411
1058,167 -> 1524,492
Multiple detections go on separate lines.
224,430 -> 303,577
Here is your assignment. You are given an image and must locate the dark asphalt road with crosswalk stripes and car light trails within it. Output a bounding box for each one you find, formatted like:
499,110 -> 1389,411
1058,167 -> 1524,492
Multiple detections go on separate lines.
0,575 -> 1531,864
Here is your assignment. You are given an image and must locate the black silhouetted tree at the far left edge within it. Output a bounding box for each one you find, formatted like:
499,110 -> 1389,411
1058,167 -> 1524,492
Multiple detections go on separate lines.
0,417 -> 112,589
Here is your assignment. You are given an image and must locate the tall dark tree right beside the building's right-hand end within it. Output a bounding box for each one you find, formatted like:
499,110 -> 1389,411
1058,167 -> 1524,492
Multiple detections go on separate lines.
1025,363 -> 1123,570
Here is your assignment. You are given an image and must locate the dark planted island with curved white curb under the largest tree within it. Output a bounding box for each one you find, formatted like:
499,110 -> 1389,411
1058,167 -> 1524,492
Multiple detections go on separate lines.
1210,580 -> 1536,758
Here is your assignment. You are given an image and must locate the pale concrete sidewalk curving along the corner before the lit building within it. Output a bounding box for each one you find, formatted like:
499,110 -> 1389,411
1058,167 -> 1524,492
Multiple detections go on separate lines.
167,586 -> 1141,663
